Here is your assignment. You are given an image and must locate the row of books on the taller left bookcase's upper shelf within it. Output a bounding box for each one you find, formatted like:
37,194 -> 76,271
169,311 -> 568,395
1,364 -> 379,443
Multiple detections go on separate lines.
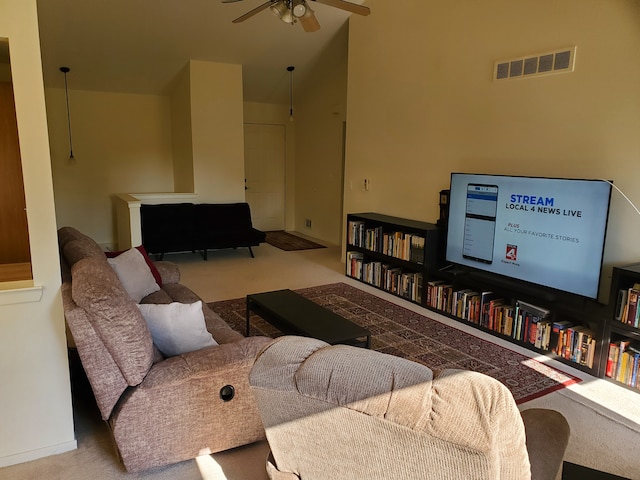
347,220 -> 425,264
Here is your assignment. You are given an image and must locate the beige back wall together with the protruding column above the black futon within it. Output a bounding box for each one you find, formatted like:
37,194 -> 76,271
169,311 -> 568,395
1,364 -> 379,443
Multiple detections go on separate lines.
46,61 -> 249,248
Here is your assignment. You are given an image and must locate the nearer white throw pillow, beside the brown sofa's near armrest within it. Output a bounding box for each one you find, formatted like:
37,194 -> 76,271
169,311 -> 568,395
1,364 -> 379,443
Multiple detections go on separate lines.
138,300 -> 218,357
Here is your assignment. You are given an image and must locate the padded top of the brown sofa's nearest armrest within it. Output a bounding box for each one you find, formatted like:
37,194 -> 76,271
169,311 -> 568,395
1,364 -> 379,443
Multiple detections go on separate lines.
138,337 -> 271,390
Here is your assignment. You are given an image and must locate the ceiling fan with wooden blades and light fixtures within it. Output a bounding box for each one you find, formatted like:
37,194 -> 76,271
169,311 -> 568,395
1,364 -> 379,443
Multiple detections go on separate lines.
222,0 -> 371,32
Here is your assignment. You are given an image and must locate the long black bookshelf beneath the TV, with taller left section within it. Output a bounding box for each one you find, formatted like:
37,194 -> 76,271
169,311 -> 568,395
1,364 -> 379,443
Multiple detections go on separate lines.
345,213 -> 604,377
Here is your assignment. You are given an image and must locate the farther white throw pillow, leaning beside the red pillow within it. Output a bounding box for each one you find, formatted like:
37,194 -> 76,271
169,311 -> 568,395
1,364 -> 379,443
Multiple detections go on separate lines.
107,248 -> 160,303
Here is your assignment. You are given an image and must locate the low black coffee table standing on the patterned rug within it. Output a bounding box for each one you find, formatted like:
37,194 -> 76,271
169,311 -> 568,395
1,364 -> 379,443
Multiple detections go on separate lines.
247,290 -> 371,348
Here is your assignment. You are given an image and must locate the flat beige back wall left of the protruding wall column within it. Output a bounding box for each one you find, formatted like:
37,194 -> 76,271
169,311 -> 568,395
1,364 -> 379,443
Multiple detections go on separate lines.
46,88 -> 173,246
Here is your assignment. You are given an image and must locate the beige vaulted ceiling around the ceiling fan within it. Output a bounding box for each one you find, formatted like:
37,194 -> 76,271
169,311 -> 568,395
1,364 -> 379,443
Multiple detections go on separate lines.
38,0 -> 363,103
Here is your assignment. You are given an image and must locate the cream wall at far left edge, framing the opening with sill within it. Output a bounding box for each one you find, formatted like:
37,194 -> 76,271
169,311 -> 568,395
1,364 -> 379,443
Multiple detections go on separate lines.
0,0 -> 76,467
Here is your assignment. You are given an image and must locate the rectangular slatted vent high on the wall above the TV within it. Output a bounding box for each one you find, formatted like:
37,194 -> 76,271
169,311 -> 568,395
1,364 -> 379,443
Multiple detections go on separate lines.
493,45 -> 576,80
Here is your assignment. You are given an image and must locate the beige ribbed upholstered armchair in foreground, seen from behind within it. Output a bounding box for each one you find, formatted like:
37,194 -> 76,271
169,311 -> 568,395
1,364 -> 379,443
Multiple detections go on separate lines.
250,337 -> 569,480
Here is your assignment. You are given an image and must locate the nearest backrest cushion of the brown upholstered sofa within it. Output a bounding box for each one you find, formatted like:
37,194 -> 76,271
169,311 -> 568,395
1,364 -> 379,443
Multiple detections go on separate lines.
71,256 -> 155,386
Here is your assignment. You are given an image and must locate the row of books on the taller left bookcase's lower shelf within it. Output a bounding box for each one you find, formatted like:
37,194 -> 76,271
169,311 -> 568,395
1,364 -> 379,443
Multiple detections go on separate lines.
347,252 -> 424,303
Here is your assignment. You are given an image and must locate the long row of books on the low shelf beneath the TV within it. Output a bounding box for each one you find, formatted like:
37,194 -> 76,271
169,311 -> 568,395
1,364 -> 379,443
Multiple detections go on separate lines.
427,280 -> 596,368
